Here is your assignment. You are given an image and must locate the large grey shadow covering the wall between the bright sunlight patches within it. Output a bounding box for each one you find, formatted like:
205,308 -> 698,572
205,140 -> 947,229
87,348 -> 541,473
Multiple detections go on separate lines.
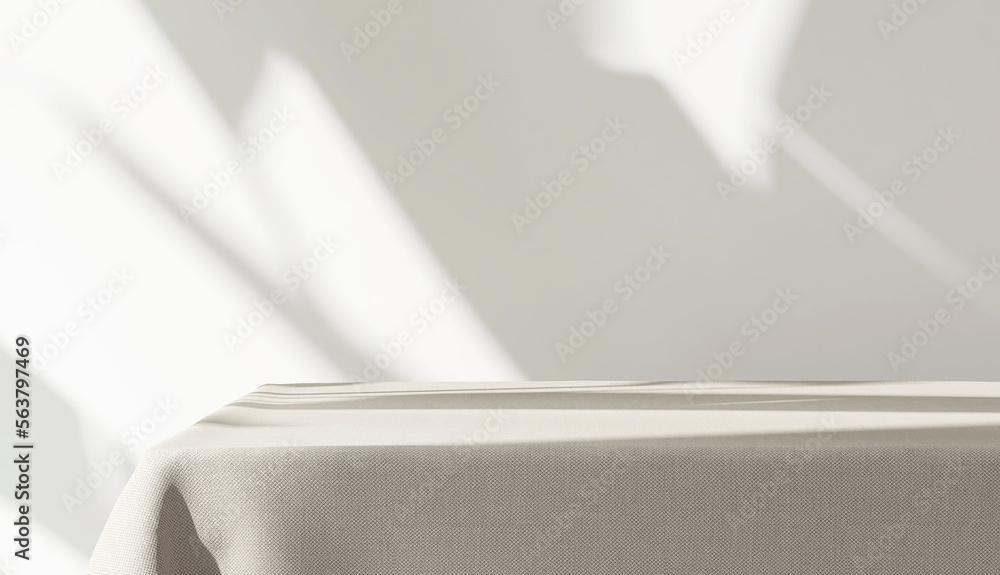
109,0 -> 1000,380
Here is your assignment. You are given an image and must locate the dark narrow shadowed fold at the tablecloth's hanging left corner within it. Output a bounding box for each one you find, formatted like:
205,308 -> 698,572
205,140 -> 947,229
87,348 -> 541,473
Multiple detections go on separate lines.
156,485 -> 221,575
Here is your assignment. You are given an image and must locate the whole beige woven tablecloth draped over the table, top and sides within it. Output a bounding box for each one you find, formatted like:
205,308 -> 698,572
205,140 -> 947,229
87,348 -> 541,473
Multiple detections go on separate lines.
88,382 -> 1000,575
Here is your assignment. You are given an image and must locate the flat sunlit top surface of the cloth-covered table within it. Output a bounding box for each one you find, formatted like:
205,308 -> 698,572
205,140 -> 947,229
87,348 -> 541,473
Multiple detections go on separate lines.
157,382 -> 1000,450
